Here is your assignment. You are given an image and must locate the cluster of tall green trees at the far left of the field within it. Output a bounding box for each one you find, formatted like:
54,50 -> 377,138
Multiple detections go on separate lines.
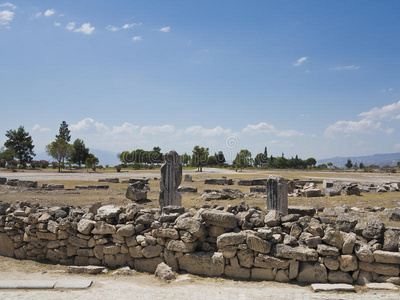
0,121 -> 99,171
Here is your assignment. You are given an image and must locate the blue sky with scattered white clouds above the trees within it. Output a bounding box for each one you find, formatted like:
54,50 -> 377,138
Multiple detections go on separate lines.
0,0 -> 400,164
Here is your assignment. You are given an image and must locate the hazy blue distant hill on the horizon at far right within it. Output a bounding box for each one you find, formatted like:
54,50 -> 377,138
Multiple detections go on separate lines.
317,153 -> 400,168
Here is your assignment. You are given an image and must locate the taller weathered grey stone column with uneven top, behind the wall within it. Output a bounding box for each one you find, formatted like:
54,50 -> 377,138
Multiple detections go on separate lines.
159,151 -> 182,208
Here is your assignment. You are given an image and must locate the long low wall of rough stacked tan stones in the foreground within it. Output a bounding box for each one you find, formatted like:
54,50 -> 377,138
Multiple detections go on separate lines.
0,202 -> 400,284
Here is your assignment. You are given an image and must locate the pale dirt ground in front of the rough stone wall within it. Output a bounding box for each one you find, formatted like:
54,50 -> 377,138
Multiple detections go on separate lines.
0,257 -> 400,300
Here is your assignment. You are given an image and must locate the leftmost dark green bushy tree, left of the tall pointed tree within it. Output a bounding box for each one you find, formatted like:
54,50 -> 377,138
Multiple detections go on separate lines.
4,126 -> 36,165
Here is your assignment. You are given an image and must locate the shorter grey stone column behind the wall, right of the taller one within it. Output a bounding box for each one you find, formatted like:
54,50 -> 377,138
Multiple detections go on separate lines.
267,175 -> 288,215
